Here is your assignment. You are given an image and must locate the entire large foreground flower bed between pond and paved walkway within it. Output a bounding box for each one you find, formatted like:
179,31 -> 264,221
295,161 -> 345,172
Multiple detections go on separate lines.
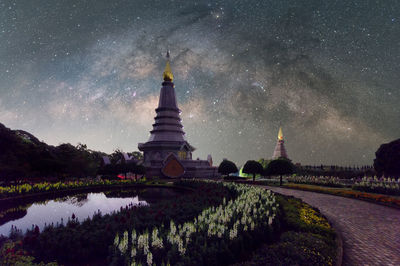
0,180 -> 335,265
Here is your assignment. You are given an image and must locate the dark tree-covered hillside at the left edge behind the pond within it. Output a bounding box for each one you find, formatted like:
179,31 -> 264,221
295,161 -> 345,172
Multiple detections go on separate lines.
0,123 -> 103,181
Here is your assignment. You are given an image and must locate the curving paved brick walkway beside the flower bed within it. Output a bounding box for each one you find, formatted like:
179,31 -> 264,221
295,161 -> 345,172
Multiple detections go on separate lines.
267,187 -> 400,266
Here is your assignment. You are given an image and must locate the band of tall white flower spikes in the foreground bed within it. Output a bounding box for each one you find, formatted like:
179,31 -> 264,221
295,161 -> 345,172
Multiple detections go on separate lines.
113,183 -> 279,265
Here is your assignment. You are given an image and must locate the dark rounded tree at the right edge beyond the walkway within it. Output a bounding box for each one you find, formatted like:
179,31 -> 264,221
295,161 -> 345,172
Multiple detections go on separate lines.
374,139 -> 400,177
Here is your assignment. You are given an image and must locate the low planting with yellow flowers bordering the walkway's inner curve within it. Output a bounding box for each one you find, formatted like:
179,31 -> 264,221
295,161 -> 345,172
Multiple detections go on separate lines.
236,195 -> 340,266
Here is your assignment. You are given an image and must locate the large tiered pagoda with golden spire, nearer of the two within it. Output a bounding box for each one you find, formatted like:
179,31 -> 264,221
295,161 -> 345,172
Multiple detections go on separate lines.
138,52 -> 219,178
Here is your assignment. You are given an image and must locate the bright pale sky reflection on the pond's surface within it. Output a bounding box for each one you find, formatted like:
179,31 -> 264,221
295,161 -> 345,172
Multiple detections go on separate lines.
0,191 -> 147,235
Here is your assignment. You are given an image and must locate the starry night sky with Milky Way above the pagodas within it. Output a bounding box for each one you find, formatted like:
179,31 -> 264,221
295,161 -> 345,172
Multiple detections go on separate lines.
0,0 -> 400,165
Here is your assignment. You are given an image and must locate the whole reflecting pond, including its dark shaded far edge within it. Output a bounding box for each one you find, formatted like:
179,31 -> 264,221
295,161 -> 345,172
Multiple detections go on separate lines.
0,188 -> 182,236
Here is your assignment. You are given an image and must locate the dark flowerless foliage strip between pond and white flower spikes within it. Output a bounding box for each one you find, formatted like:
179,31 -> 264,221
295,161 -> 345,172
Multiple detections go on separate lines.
17,181 -> 236,264
